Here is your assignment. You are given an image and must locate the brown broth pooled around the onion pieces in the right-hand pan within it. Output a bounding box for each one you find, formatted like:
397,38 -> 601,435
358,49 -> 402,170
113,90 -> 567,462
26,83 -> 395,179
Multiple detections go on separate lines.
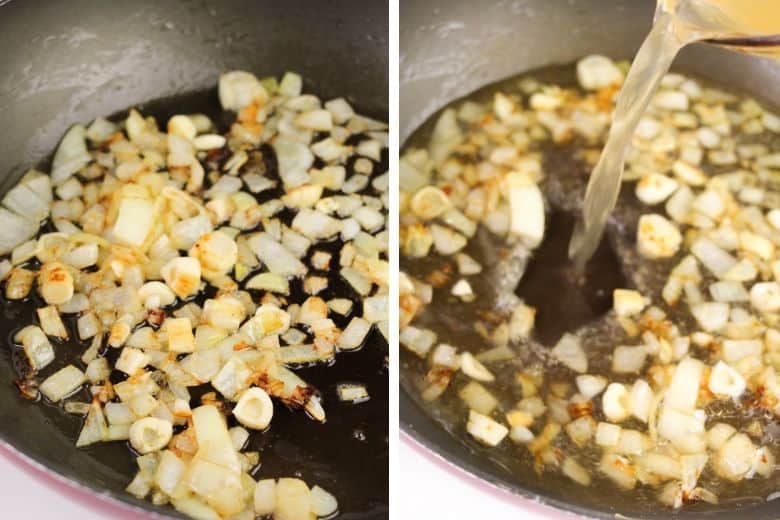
399,57 -> 780,518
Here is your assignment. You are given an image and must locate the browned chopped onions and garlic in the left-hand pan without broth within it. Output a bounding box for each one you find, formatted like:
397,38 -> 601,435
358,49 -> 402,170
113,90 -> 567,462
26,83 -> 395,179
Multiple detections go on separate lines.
0,71 -> 388,520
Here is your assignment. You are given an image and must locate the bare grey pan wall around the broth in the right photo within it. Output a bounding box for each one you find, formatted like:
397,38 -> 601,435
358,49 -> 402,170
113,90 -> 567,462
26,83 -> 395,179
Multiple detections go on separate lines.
399,0 -> 780,519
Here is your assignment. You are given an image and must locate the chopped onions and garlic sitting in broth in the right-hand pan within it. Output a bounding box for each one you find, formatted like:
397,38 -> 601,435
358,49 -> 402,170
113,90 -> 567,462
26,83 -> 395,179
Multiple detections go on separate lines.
400,56 -> 780,508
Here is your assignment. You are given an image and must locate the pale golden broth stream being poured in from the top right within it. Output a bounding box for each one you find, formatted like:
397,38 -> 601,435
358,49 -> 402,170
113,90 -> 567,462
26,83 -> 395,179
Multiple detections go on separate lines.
569,0 -> 780,271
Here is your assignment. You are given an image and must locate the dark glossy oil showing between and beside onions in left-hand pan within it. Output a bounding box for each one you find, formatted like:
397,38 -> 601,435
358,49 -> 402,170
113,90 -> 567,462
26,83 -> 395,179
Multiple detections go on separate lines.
0,91 -> 389,518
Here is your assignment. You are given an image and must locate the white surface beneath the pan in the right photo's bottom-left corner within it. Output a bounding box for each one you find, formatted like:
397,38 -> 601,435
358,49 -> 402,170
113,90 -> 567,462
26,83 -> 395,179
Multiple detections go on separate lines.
398,435 -> 575,520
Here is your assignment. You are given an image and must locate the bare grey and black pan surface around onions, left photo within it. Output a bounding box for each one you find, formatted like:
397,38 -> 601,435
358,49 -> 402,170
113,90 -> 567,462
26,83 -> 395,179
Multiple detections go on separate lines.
0,0 -> 388,518
